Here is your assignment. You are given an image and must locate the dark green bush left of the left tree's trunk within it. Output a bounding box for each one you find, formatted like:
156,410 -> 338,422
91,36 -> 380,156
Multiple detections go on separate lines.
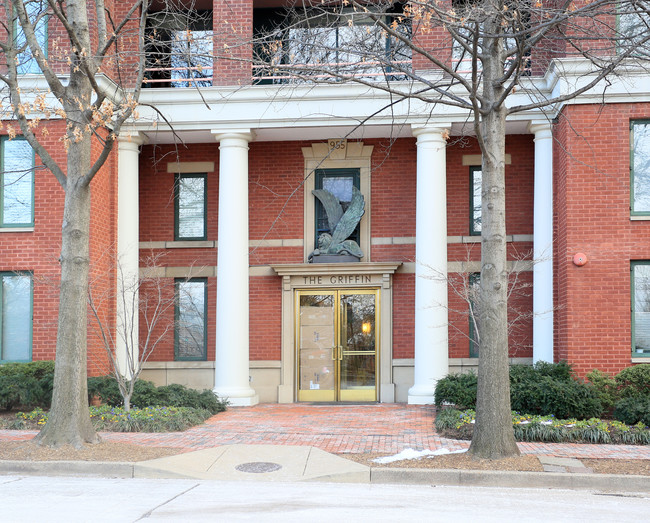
0,361 -> 54,410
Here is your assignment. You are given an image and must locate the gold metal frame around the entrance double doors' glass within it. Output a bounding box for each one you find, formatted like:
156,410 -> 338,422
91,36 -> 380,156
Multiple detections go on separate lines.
294,288 -> 381,402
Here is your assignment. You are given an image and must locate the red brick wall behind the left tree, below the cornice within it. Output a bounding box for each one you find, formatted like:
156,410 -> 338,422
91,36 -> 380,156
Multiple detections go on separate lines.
0,121 -> 117,374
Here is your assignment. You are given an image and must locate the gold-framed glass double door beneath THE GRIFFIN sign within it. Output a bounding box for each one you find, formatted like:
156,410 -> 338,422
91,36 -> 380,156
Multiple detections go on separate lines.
296,289 -> 379,402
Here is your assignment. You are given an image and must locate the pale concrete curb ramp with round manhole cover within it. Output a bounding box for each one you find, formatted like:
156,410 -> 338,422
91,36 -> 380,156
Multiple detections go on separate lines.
133,445 -> 370,482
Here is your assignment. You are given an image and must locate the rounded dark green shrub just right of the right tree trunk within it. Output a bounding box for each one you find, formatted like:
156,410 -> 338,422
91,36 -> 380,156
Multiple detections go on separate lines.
510,376 -> 603,419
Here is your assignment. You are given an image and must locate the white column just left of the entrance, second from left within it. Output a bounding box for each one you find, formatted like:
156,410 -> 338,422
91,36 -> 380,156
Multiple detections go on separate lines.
212,130 -> 259,406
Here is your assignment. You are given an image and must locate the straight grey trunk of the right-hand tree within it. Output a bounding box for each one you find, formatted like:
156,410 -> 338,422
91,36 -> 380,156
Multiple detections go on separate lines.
469,12 -> 519,459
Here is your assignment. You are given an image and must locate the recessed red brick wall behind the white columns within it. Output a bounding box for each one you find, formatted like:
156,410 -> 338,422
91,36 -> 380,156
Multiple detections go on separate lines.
140,135 -> 534,360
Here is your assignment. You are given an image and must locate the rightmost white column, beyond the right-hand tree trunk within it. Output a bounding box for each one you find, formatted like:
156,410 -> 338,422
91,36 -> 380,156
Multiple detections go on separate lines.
529,121 -> 553,362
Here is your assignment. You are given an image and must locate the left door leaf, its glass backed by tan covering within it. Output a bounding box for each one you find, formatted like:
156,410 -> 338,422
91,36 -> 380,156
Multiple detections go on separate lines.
297,292 -> 337,401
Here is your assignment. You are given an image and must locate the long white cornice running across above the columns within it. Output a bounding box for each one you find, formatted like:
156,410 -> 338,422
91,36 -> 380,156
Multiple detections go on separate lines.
7,58 -> 650,143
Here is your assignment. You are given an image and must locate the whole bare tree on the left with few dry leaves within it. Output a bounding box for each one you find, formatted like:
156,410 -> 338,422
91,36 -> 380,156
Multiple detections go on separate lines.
0,0 -> 149,447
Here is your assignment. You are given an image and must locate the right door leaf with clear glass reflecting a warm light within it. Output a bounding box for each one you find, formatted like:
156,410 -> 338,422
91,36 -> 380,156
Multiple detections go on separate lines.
339,291 -> 377,401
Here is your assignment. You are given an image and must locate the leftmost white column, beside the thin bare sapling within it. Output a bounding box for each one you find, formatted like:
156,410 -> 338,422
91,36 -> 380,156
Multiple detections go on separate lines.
115,133 -> 144,377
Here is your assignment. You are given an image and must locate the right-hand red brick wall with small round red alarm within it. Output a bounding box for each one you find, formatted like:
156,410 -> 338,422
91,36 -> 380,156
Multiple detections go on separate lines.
554,104 -> 650,374
